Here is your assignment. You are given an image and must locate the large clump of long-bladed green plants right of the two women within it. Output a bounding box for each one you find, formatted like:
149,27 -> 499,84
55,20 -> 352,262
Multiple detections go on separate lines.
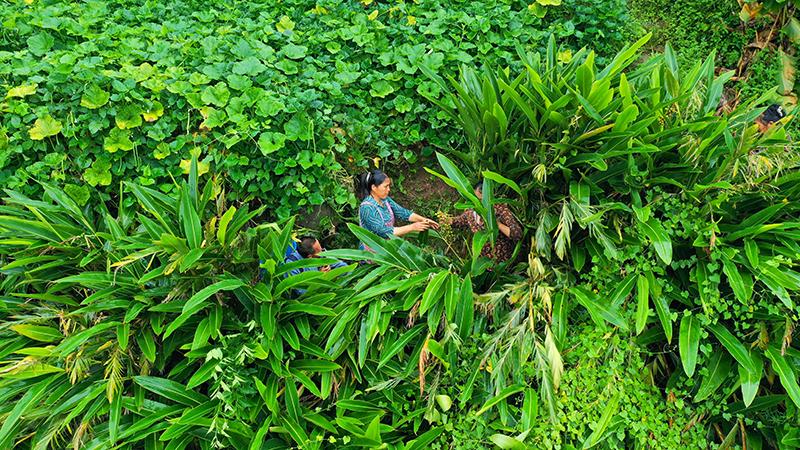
428,33 -> 800,448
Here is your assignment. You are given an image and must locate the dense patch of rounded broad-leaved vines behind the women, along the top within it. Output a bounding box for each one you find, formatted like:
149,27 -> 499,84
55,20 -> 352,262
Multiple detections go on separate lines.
0,0 -> 626,218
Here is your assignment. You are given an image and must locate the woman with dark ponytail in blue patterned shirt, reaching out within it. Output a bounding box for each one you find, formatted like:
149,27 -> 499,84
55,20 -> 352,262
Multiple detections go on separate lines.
355,170 -> 439,251
